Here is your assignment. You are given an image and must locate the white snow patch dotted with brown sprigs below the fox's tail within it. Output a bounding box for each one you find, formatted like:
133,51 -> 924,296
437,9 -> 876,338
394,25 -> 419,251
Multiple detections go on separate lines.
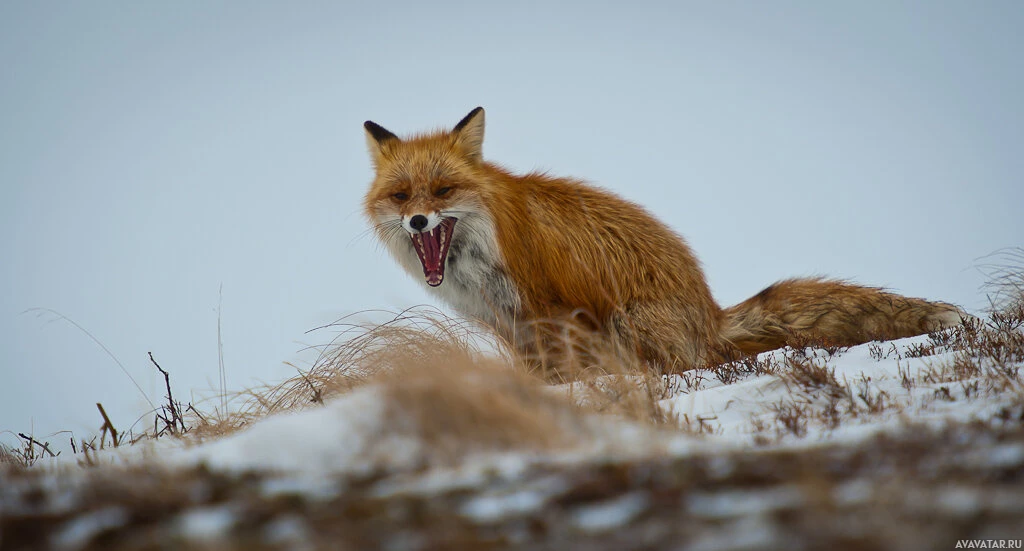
659,335 -> 1024,446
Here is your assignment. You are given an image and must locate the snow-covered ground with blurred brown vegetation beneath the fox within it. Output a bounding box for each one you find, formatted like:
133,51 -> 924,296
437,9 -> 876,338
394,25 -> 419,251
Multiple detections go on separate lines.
0,321 -> 1024,549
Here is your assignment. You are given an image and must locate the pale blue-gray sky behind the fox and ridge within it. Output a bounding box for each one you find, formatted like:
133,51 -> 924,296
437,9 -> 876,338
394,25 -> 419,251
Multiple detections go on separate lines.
0,0 -> 1024,442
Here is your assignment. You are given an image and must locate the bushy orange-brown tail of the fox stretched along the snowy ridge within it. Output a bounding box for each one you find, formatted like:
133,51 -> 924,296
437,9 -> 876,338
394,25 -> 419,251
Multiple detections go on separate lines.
722,279 -> 967,354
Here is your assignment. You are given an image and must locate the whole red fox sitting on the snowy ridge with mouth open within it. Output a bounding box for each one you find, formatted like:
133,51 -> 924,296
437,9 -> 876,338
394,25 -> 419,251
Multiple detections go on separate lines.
364,108 -> 963,376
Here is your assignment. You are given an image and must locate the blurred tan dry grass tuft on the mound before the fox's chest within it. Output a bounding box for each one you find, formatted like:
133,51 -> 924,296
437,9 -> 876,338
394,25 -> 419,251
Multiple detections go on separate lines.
174,308 -> 679,459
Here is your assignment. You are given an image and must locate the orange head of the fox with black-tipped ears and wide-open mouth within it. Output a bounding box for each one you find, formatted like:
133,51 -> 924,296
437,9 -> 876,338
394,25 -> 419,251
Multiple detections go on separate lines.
364,108 -> 485,287
